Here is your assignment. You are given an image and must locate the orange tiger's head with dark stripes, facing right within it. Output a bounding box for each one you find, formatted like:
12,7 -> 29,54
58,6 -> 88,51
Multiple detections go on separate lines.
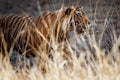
62,5 -> 90,34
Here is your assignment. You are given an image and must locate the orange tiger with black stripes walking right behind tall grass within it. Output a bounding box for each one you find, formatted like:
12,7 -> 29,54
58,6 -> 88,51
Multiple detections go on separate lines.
0,6 -> 90,57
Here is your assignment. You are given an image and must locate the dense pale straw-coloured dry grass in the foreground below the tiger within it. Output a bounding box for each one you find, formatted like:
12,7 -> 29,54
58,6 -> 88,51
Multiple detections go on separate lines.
0,36 -> 120,80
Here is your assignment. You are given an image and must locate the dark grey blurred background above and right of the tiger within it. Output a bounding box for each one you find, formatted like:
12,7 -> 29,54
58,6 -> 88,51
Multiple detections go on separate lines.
0,0 -> 120,52
